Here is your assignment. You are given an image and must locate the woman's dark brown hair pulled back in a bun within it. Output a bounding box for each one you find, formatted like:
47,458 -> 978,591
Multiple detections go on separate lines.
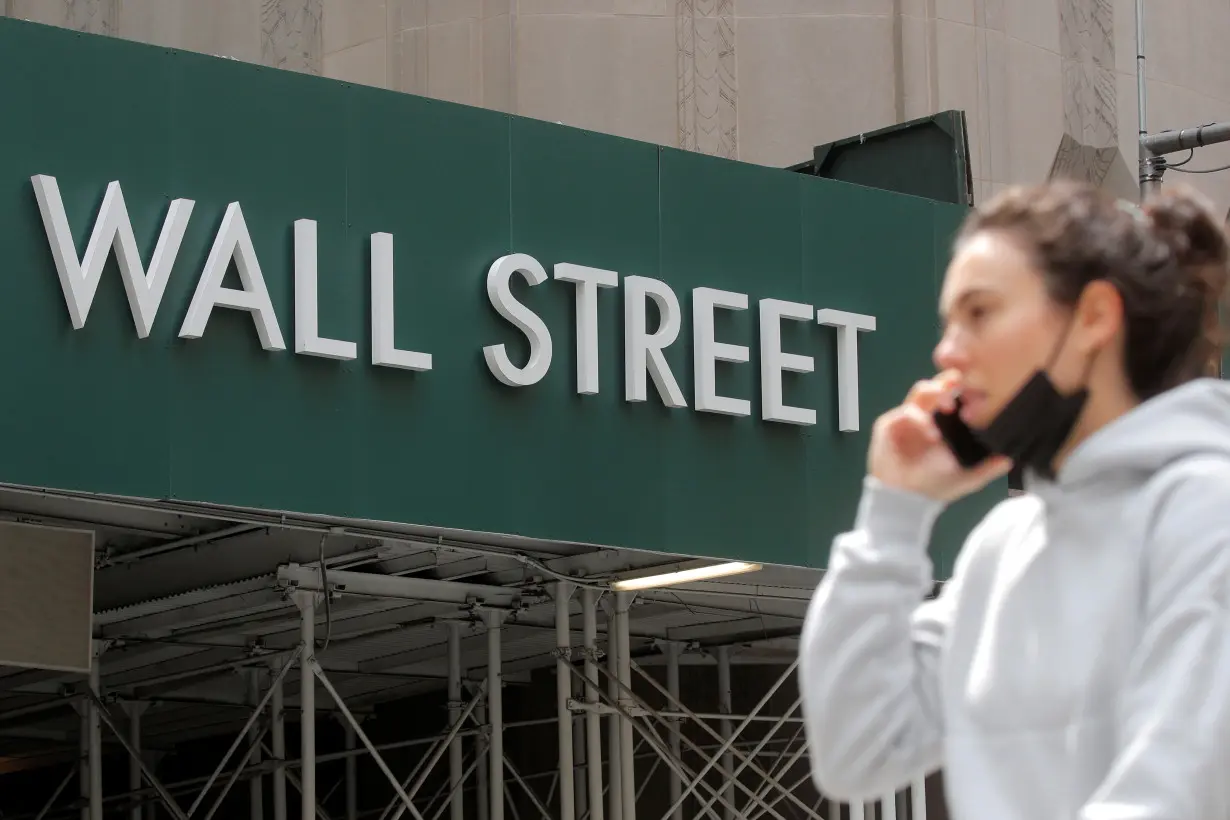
957,179 -> 1230,400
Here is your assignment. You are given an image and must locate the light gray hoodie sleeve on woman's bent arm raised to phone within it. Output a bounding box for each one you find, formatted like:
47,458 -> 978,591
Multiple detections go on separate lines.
800,478 -> 957,800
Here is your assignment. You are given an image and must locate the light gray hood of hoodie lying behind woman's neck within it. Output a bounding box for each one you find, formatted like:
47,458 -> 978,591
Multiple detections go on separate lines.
1027,379 -> 1230,488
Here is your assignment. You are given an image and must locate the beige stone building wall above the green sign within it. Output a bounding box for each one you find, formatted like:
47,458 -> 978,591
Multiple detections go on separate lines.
0,0 -> 1230,215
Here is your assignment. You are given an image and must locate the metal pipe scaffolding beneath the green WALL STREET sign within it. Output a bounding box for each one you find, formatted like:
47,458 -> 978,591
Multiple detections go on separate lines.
0,493 -> 937,820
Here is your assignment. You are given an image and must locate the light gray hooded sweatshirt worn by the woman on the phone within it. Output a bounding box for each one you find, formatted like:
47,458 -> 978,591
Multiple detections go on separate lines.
800,379 -> 1230,820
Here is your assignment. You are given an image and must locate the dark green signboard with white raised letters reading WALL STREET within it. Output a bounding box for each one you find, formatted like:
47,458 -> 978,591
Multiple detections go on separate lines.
0,14 -> 1002,575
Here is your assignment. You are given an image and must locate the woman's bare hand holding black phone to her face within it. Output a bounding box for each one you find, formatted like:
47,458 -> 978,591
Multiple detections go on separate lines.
867,374 -> 1012,502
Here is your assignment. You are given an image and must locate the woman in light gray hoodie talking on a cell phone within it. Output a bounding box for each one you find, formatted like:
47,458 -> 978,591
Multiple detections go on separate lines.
800,182 -> 1230,820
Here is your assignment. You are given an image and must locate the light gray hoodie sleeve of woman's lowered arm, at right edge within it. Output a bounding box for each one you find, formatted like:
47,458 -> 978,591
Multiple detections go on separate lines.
1079,460 -> 1230,820
